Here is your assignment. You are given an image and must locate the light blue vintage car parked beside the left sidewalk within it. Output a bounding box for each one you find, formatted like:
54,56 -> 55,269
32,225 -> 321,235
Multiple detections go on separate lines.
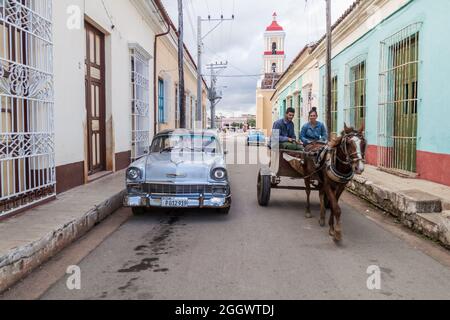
124,130 -> 231,214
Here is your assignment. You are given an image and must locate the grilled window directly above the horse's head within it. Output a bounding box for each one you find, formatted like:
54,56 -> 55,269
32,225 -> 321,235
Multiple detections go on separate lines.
344,55 -> 367,129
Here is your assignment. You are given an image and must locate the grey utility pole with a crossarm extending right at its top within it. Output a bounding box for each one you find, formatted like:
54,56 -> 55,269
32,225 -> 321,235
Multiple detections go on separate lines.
195,15 -> 234,129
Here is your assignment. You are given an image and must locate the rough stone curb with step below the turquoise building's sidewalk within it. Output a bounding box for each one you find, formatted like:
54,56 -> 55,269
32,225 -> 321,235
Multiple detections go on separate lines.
347,176 -> 450,249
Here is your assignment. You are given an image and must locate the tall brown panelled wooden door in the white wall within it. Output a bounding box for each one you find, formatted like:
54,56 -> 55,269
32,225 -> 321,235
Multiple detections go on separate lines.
85,23 -> 106,175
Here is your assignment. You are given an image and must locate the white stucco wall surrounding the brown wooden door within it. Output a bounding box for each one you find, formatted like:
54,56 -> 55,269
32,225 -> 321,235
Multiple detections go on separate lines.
53,0 -> 154,166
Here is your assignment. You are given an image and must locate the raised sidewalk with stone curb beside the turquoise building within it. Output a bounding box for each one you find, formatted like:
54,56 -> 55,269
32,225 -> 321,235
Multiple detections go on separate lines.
348,166 -> 450,248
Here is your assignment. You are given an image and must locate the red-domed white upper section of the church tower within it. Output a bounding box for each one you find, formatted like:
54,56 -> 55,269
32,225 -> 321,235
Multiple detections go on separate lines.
264,12 -> 286,74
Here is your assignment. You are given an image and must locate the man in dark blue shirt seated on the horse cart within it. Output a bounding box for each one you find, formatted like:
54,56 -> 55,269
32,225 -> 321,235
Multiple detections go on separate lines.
272,108 -> 303,150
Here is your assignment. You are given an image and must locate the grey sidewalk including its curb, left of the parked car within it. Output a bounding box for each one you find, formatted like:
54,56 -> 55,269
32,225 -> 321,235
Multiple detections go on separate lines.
0,171 -> 125,293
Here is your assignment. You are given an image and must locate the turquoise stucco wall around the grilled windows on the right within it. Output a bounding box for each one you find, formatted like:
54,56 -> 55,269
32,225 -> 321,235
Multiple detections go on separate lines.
320,0 -> 450,154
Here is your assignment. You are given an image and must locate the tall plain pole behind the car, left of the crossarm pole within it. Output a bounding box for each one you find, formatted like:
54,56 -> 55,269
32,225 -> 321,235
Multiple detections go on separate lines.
178,0 -> 186,129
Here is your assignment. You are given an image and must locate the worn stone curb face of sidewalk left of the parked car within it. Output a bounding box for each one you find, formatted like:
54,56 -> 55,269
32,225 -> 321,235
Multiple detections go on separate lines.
0,190 -> 125,293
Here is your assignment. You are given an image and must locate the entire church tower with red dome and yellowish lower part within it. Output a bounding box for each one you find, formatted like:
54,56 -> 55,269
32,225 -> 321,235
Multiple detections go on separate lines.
256,13 -> 286,134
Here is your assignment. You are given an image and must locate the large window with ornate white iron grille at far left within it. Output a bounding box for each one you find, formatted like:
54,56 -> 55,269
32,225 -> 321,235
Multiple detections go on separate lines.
0,0 -> 56,216
